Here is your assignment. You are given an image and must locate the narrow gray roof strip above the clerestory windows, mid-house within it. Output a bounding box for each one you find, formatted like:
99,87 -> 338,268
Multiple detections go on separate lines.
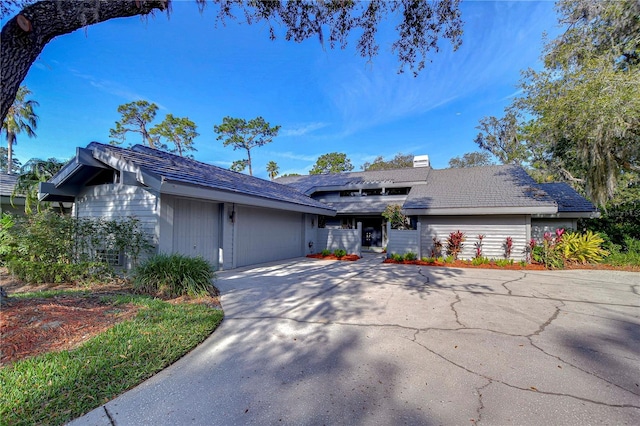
276,167 -> 431,194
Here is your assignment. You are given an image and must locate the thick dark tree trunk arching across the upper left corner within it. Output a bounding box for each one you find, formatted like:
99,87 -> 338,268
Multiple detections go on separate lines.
0,0 -> 169,122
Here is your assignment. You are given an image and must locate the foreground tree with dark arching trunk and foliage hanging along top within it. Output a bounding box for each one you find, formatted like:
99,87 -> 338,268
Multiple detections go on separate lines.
0,0 -> 462,125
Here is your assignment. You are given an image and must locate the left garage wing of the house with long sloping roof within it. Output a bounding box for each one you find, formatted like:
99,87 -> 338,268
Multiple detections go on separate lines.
39,142 -> 335,269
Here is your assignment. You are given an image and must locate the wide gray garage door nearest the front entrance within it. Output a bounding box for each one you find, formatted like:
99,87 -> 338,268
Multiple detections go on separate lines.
236,207 -> 303,266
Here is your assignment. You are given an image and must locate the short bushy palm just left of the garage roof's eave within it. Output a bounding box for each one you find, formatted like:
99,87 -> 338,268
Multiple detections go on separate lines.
10,158 -> 65,214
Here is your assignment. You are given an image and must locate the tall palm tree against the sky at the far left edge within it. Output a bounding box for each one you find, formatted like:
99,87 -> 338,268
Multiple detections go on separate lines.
2,86 -> 39,173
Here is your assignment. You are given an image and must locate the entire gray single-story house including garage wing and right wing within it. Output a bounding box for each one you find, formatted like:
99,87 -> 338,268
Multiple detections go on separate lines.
40,142 -> 598,269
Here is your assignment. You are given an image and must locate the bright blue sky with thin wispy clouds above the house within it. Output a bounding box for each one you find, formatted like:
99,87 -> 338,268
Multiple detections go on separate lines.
2,0 -> 560,177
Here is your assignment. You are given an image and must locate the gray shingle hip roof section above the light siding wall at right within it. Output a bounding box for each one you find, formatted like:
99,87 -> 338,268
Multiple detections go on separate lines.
404,165 -> 555,209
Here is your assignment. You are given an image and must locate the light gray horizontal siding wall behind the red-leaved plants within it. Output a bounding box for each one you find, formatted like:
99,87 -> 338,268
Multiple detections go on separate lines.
420,215 -> 531,260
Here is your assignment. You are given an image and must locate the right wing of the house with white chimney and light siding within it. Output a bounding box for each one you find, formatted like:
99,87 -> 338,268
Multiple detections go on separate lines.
276,156 -> 599,259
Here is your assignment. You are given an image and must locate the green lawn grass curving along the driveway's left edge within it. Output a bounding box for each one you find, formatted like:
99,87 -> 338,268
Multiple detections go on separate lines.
0,295 -> 223,425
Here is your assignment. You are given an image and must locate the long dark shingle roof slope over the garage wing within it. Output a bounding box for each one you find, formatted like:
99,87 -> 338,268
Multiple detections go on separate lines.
87,142 -> 331,209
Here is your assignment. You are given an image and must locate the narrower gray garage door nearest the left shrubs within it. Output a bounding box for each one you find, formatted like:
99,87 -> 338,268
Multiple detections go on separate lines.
173,198 -> 220,268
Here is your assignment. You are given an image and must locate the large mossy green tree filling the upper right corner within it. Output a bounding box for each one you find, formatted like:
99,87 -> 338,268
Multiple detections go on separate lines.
476,0 -> 640,205
